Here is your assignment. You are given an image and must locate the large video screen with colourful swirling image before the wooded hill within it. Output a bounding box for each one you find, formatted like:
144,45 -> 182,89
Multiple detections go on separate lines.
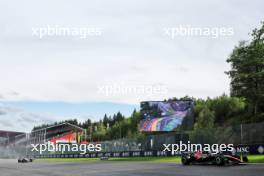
140,101 -> 194,132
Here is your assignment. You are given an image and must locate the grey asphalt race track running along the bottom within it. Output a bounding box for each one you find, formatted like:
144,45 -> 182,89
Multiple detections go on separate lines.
0,160 -> 264,176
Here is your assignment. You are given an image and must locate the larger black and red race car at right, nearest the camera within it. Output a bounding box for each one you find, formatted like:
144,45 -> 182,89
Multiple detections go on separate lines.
181,151 -> 244,166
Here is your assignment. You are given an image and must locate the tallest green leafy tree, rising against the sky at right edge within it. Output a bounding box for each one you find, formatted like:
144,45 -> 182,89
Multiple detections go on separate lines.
227,23 -> 264,116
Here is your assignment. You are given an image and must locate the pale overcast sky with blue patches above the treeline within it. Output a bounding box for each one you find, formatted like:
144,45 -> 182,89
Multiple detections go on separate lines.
0,0 -> 264,130
